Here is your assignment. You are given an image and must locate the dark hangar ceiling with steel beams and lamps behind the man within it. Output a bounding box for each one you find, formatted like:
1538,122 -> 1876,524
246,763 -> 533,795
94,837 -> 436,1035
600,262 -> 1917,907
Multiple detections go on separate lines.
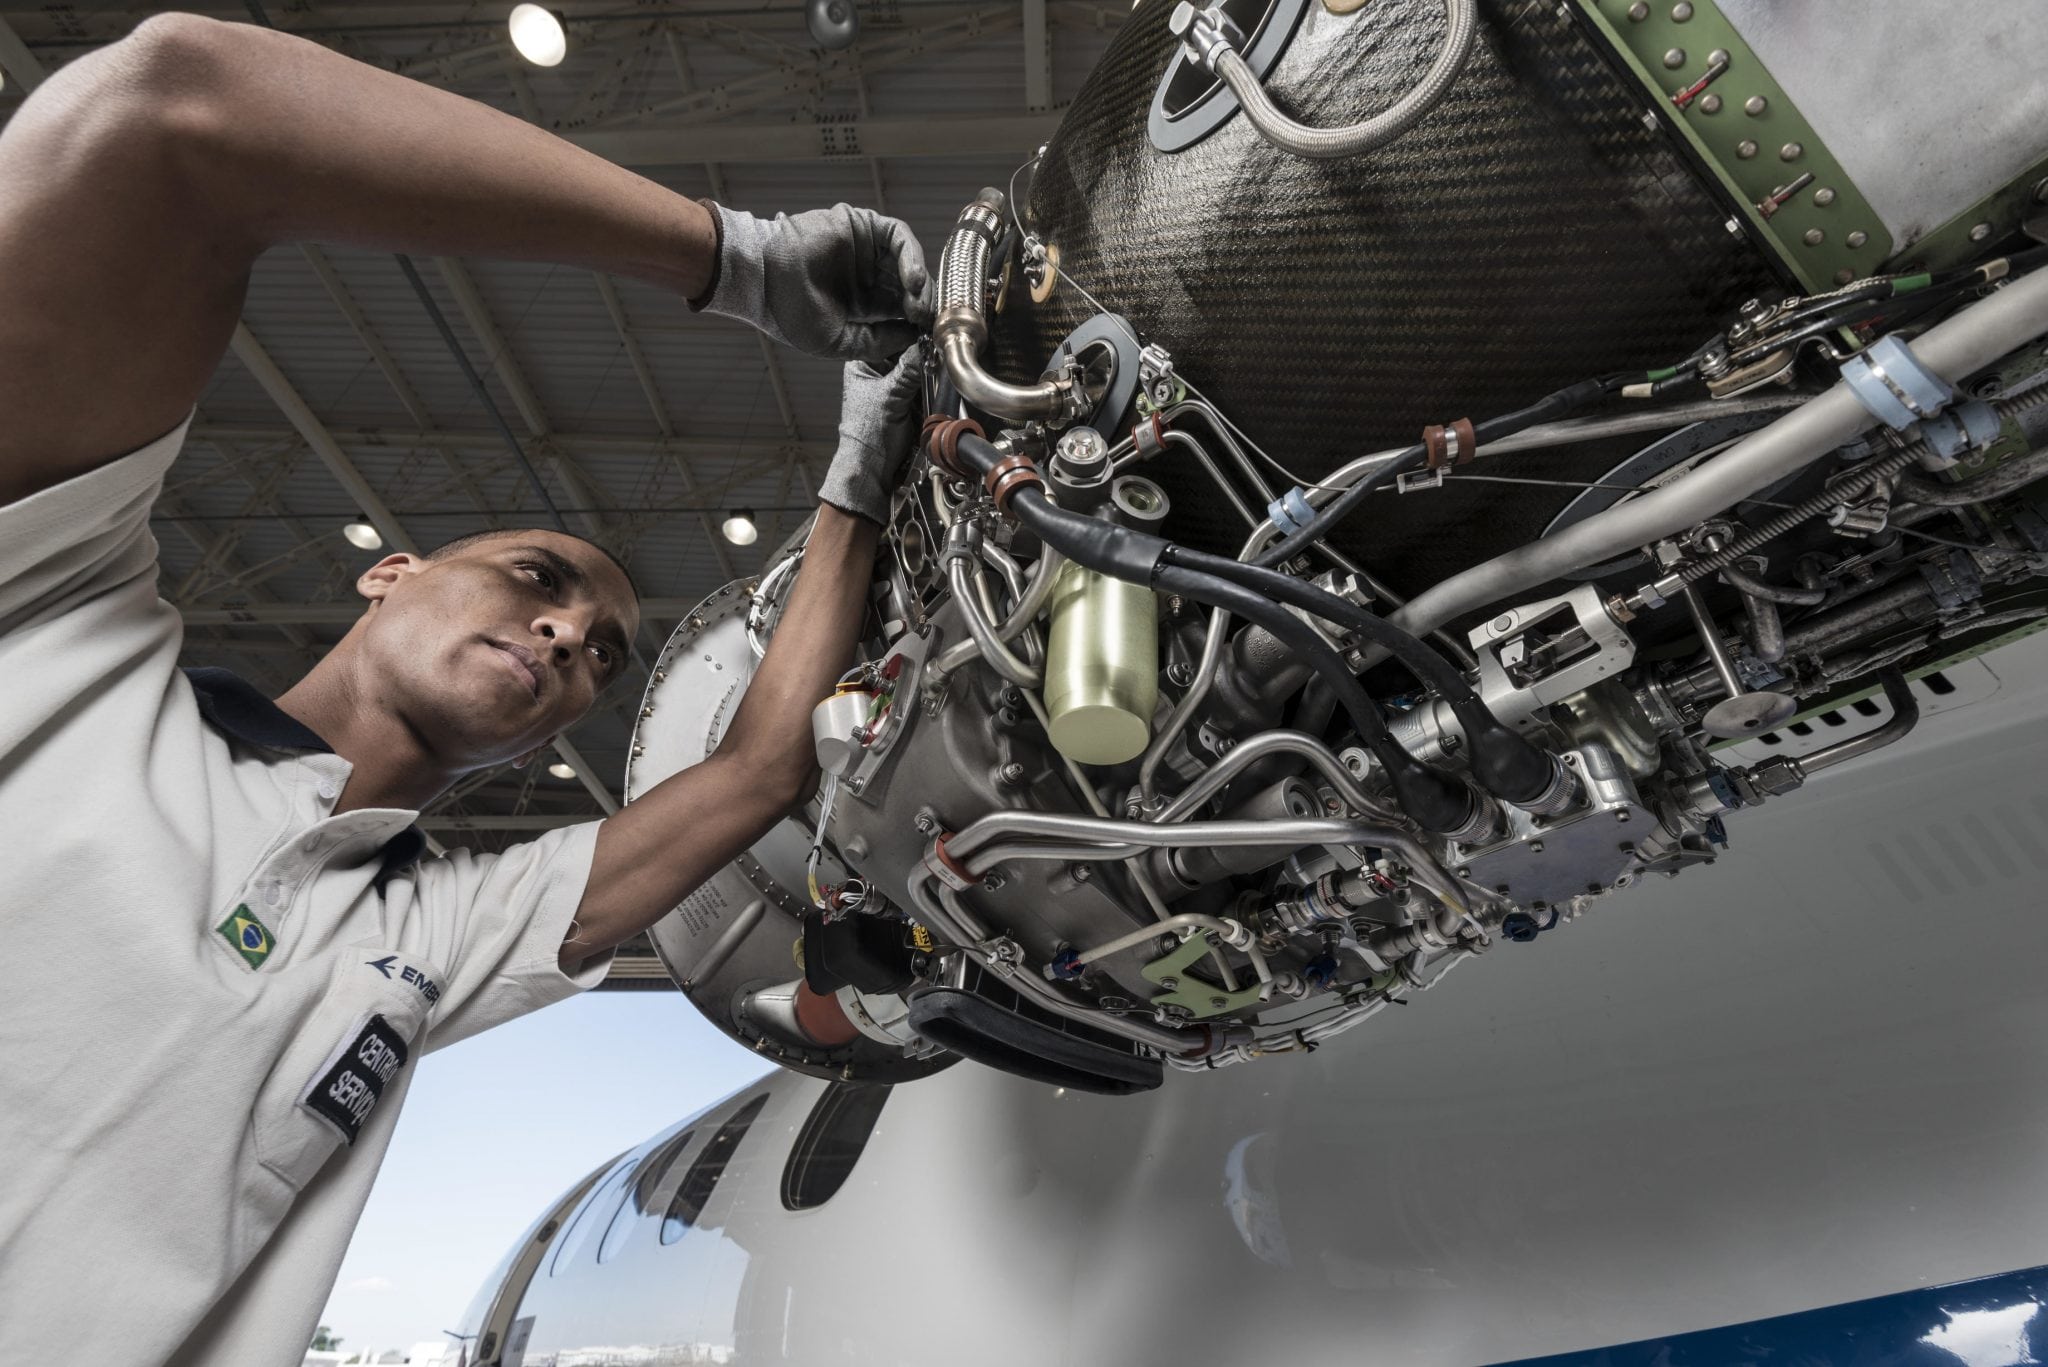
0,0 -> 1126,984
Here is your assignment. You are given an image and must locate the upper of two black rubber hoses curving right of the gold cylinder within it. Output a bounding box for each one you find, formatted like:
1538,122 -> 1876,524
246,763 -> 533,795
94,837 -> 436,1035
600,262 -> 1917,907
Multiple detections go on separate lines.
1165,543 -> 1556,803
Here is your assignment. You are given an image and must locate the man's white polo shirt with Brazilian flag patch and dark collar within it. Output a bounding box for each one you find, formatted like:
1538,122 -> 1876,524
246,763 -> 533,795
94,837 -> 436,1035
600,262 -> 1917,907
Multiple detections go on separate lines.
0,426 -> 610,1367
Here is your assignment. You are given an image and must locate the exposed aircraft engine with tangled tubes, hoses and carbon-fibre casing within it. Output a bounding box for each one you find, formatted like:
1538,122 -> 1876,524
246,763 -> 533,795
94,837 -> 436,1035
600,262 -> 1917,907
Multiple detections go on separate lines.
627,0 -> 2048,1092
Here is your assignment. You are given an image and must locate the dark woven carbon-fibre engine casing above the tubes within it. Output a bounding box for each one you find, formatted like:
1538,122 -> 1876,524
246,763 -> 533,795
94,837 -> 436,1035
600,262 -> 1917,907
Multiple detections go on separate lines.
989,0 -> 1772,592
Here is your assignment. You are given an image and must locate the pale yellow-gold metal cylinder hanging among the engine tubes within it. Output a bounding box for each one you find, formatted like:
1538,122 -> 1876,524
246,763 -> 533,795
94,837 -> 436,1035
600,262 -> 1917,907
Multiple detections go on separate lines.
1044,564 -> 1159,764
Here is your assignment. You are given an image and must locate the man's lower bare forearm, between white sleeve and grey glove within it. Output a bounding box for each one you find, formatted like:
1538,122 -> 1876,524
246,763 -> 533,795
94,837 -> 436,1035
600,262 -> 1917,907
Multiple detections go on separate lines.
561,504 -> 881,969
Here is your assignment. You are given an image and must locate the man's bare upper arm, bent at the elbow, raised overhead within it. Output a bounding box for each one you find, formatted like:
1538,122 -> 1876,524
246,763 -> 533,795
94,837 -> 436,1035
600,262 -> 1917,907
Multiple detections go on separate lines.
0,14 -> 715,504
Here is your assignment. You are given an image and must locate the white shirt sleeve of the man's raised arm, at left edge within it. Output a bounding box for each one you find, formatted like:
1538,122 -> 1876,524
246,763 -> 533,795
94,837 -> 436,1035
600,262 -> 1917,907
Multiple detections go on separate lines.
0,420 -> 190,756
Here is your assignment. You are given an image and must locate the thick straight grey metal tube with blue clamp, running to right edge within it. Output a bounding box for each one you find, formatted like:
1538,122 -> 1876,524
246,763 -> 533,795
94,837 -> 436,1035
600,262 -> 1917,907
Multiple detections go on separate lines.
1393,271 -> 2048,651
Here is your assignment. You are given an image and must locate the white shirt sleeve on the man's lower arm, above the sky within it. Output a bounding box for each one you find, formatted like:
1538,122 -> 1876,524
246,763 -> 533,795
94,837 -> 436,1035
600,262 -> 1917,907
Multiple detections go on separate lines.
387,822 -> 612,1049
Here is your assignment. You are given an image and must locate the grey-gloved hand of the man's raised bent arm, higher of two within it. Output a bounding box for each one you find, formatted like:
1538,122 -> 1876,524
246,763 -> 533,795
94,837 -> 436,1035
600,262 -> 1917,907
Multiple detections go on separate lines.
690,201 -> 936,363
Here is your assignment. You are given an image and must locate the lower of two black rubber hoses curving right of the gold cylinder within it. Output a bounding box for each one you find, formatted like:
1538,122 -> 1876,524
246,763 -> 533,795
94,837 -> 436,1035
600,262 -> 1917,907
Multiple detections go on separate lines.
1146,565 -> 1477,832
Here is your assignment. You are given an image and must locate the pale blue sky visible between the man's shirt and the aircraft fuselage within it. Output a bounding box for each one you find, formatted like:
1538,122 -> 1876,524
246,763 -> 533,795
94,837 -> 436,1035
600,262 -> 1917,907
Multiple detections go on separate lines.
319,992 -> 766,1351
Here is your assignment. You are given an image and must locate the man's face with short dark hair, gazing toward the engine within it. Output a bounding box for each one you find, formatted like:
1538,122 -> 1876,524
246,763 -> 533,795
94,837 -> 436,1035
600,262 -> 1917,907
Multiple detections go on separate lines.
360,531 -> 639,769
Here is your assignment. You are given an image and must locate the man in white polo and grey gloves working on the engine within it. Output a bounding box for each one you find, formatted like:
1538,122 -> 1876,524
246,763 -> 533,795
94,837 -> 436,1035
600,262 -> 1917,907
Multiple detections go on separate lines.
0,16 -> 930,1367
